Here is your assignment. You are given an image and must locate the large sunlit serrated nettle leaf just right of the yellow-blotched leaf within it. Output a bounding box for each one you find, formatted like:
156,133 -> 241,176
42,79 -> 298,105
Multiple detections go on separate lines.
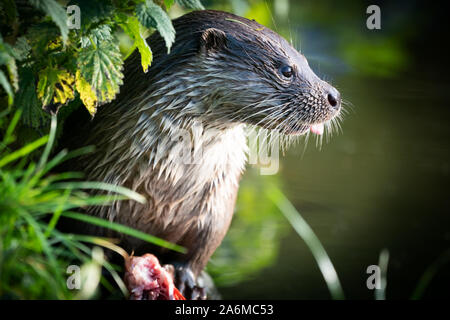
77,41 -> 123,112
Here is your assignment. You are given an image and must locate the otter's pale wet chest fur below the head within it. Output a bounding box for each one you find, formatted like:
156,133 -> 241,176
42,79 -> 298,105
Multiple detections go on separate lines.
118,126 -> 247,244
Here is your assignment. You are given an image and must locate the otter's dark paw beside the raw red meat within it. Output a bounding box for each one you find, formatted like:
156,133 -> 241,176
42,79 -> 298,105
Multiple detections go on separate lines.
174,265 -> 206,300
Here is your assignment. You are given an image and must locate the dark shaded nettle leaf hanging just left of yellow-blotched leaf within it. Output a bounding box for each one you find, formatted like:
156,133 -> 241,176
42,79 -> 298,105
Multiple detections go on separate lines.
14,68 -> 49,128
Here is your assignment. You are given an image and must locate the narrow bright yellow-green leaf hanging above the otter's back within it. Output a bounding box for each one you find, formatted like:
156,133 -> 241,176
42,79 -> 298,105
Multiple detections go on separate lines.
119,16 -> 153,72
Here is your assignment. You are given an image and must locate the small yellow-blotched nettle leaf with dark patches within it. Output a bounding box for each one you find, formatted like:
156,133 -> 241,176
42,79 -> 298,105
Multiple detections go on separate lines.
37,66 -> 74,109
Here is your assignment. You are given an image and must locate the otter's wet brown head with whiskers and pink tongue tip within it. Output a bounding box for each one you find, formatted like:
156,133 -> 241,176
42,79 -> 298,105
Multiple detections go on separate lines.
183,12 -> 341,135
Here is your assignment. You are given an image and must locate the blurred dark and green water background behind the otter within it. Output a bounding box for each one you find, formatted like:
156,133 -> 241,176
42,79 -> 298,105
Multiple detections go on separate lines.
195,0 -> 450,299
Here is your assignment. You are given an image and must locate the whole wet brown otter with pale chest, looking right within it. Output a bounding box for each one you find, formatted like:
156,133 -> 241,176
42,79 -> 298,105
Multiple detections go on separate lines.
65,10 -> 341,297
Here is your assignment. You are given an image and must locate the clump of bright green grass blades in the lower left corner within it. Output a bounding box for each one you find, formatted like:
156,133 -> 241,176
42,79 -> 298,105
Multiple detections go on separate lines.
0,112 -> 184,299
